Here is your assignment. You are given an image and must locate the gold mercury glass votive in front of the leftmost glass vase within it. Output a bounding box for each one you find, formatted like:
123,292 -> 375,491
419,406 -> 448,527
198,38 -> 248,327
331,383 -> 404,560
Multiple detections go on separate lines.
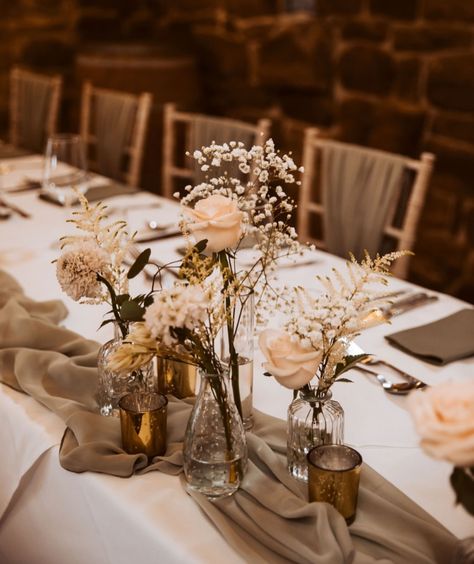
119,392 -> 168,458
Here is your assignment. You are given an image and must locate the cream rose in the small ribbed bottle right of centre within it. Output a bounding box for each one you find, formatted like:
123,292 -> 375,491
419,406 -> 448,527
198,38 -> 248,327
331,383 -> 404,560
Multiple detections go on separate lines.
258,329 -> 321,390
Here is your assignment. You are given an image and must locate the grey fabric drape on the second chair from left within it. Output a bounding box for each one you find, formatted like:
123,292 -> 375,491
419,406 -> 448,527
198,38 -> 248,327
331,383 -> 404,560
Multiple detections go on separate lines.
92,92 -> 137,180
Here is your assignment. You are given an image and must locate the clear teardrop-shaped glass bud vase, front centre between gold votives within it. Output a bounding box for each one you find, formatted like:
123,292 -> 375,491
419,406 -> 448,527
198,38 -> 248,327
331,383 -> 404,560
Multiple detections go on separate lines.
183,371 -> 247,498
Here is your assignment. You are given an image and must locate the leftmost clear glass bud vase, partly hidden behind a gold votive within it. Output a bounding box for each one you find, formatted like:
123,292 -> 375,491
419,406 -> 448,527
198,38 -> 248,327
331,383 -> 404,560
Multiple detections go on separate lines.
97,326 -> 156,417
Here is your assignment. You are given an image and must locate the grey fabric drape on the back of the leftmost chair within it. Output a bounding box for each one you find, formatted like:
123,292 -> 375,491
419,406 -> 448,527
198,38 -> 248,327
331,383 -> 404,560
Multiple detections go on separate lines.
18,75 -> 52,153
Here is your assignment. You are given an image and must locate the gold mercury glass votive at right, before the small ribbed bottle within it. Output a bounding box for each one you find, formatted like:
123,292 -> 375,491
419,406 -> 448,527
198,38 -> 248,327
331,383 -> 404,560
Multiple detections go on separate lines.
307,445 -> 362,525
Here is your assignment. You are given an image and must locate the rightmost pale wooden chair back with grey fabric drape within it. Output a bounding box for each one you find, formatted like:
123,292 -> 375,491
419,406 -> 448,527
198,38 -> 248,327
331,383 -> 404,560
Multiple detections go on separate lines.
298,128 -> 435,278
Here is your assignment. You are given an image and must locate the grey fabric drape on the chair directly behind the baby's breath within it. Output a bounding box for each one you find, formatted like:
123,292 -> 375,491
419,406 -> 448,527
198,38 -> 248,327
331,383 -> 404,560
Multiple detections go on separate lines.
191,115 -> 255,184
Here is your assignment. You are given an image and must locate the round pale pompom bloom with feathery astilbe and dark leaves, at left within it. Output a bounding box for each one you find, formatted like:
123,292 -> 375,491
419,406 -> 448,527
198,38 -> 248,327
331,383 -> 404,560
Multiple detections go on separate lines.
55,194 -> 156,337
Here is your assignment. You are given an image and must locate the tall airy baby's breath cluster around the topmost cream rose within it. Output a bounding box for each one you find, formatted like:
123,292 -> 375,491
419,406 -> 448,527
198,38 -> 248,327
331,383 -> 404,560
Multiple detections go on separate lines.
175,139 -> 312,322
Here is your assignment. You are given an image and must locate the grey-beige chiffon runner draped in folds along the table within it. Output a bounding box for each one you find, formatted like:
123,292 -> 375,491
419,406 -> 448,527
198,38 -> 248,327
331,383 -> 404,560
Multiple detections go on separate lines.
0,272 -> 457,564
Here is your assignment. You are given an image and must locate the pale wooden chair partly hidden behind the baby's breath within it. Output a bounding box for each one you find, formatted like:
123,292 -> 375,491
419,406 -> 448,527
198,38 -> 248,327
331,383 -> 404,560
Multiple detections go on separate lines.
161,104 -> 271,198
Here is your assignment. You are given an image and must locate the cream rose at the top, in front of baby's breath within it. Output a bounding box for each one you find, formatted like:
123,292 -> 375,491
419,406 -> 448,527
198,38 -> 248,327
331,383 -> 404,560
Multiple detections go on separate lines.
186,194 -> 244,253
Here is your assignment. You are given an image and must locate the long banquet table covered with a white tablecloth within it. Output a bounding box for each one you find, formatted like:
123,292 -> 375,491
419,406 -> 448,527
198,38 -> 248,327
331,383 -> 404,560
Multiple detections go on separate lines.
0,152 -> 474,564
